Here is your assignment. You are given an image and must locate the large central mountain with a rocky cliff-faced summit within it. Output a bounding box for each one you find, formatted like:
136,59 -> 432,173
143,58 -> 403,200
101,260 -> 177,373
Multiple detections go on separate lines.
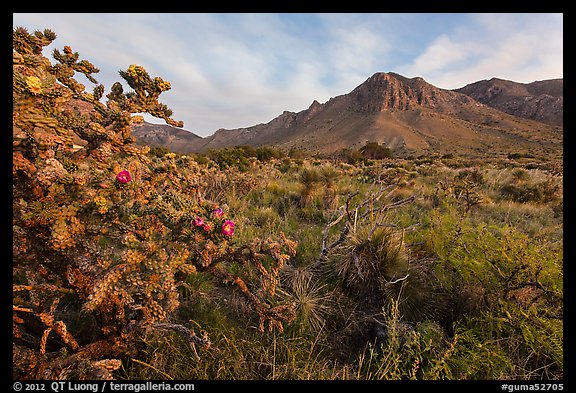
184,72 -> 562,155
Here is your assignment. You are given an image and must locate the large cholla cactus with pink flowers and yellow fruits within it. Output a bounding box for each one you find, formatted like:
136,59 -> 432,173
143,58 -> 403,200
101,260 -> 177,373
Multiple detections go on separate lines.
13,27 -> 295,379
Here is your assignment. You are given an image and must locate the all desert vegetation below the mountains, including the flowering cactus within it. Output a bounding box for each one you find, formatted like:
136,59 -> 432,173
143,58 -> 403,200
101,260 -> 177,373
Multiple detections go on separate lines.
12,28 -> 564,380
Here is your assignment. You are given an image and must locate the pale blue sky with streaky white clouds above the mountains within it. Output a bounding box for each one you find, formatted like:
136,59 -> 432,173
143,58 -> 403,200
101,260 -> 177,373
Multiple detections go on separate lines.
13,13 -> 564,137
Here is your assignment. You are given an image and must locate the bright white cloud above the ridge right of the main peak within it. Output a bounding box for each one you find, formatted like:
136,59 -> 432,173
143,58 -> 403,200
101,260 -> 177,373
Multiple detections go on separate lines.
400,14 -> 563,89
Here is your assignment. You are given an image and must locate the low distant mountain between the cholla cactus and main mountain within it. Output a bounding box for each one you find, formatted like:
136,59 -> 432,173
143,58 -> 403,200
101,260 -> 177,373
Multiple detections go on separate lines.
131,121 -> 202,153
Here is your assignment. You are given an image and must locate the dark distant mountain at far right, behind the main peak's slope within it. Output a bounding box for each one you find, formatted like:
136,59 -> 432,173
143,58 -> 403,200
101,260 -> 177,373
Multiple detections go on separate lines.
455,78 -> 564,125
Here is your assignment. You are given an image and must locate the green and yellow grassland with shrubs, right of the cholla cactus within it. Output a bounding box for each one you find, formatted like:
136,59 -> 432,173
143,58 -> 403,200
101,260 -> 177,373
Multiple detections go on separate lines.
118,158 -> 563,380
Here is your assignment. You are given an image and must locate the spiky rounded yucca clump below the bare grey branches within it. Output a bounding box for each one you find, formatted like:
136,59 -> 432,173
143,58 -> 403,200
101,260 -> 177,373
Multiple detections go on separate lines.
330,227 -> 444,321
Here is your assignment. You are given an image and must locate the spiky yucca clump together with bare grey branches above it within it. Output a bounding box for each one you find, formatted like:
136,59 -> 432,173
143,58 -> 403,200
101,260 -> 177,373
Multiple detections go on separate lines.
317,176 -> 444,336
